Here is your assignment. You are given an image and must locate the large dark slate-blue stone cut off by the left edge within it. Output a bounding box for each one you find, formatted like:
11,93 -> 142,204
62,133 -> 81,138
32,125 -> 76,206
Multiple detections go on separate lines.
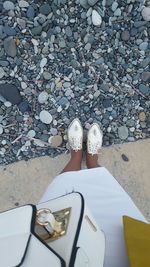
0,84 -> 21,105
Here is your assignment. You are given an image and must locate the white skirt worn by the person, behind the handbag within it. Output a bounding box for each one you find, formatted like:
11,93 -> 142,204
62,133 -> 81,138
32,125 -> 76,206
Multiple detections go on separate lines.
40,167 -> 146,267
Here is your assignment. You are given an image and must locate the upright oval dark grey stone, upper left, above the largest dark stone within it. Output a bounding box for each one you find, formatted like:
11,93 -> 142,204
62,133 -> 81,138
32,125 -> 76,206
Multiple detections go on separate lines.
4,37 -> 17,57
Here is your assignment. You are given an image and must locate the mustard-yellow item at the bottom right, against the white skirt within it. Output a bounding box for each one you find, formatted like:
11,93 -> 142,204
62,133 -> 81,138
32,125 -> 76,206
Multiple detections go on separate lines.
123,216 -> 150,267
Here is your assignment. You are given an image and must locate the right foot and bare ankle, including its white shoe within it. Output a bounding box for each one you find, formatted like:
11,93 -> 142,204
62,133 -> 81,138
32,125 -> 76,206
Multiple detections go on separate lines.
86,123 -> 103,169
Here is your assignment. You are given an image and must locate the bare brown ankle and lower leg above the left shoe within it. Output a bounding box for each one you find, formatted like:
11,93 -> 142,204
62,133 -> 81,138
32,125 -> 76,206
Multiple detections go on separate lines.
61,149 -> 82,173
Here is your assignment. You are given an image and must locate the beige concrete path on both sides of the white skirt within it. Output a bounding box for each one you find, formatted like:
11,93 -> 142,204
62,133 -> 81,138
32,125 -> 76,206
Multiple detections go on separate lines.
0,139 -> 150,221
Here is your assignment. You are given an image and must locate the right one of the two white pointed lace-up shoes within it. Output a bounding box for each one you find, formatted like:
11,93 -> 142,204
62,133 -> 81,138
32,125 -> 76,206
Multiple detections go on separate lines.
87,123 -> 103,155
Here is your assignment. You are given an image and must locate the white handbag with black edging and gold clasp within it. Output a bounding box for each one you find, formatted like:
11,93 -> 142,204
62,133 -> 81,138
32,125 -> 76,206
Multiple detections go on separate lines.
0,192 -> 105,267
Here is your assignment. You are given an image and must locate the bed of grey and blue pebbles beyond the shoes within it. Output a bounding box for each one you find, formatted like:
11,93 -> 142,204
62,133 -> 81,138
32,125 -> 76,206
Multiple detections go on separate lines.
0,0 -> 150,164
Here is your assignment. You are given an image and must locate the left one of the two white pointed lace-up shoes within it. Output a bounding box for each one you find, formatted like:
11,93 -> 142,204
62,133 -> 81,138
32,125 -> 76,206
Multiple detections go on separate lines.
68,118 -> 83,152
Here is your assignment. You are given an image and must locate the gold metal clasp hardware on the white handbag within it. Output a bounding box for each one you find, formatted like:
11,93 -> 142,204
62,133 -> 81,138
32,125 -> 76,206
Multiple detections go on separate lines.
35,208 -> 71,242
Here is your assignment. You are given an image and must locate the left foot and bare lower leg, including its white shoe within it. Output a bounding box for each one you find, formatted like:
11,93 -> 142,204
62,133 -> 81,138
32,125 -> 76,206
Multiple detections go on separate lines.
62,119 -> 83,172
